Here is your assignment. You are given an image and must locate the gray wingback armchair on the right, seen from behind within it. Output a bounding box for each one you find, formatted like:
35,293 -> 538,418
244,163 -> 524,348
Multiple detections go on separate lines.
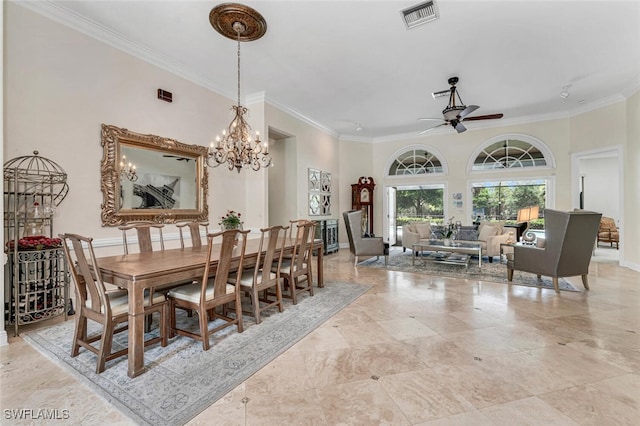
507,209 -> 602,292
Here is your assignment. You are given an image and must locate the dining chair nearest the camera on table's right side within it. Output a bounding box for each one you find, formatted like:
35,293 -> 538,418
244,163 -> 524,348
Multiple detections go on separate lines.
167,229 -> 249,351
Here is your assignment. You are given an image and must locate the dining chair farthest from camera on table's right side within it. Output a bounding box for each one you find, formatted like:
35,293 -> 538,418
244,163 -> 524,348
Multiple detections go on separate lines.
271,220 -> 316,305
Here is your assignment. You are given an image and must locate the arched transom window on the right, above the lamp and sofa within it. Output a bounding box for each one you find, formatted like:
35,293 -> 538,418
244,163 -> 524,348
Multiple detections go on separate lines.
471,139 -> 547,171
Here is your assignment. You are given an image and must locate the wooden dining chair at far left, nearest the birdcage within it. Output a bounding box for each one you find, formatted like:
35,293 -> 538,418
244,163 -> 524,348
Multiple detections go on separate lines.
59,234 -> 169,374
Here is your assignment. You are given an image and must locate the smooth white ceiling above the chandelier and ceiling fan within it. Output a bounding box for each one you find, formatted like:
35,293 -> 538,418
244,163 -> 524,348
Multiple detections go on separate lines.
25,0 -> 640,140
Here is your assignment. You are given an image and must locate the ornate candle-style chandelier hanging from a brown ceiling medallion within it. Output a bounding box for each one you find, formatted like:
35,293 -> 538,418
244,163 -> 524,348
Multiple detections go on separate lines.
207,3 -> 271,173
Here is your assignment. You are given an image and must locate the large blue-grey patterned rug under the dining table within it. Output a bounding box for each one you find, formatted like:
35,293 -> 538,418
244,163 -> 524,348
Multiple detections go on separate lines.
23,282 -> 371,425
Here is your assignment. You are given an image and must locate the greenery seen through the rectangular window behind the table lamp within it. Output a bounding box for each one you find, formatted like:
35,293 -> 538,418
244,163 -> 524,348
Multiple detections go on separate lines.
472,180 -> 547,228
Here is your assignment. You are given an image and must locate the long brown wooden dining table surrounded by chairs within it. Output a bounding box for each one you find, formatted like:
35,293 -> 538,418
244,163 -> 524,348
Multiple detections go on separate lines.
97,238 -> 324,377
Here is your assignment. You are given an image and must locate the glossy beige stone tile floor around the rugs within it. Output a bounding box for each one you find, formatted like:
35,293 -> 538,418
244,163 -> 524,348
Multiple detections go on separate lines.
0,249 -> 640,426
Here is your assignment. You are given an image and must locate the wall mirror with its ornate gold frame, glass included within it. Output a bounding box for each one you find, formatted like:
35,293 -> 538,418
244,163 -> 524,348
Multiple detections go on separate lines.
100,124 -> 209,226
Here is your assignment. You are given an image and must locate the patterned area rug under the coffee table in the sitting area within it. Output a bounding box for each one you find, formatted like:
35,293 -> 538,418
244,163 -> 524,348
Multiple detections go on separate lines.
358,248 -> 580,292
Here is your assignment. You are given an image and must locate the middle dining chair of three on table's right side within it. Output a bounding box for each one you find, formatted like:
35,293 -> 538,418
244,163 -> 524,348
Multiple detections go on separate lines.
230,226 -> 287,324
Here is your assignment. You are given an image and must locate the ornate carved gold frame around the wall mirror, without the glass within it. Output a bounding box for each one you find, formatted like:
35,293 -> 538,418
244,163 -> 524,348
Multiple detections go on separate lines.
100,124 -> 209,226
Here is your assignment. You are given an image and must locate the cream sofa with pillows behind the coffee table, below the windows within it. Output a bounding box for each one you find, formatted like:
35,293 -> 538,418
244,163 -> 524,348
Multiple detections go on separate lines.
402,222 -> 516,262
